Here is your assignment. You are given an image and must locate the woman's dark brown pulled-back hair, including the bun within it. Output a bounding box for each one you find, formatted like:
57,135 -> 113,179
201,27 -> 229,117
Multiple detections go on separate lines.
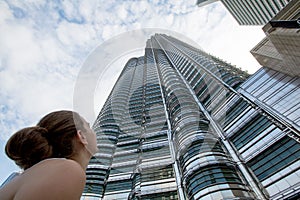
5,111 -> 84,169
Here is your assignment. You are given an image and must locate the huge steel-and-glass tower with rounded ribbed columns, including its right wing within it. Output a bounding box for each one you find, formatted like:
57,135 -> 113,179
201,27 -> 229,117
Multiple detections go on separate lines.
83,34 -> 300,199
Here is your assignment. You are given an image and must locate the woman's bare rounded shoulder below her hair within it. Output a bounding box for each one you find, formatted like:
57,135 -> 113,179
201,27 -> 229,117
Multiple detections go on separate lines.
16,159 -> 85,200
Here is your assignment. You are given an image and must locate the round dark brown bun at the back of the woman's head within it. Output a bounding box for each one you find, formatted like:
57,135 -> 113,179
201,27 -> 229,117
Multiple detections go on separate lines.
5,126 -> 52,169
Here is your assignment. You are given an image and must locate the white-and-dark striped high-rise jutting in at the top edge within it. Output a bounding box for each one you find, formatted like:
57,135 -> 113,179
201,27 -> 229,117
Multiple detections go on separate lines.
197,0 -> 290,25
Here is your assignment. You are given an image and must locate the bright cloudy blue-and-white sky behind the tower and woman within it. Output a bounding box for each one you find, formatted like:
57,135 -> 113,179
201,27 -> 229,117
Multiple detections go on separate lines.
0,0 -> 265,184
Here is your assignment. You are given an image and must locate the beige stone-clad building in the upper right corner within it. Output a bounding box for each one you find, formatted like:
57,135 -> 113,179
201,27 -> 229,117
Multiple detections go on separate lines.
251,0 -> 300,77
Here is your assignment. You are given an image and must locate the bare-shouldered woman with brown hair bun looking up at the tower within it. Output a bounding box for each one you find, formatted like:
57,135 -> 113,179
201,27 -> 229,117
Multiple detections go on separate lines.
0,111 -> 97,200
